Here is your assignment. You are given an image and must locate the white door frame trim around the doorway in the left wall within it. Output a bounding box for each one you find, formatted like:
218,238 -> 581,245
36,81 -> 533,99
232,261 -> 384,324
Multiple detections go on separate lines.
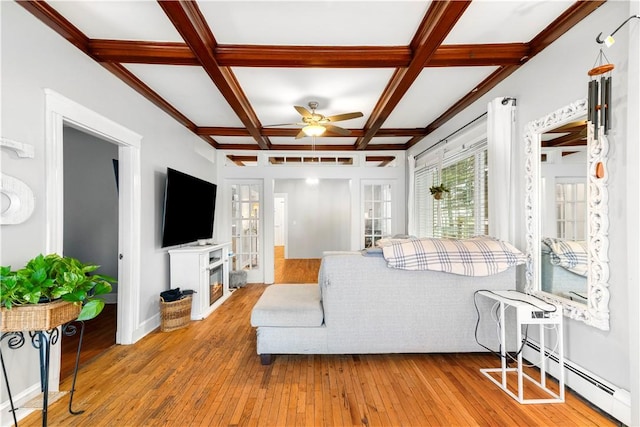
44,89 -> 142,394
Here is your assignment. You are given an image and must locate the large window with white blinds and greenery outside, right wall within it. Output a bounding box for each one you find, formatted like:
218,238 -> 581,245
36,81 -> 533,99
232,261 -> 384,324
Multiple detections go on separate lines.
414,141 -> 489,238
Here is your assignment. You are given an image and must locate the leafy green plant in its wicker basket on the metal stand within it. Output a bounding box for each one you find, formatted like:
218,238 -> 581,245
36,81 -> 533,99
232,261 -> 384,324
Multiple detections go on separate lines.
0,254 -> 116,332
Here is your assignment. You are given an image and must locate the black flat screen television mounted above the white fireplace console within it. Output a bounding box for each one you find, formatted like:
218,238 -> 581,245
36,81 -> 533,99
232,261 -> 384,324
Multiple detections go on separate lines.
162,168 -> 217,248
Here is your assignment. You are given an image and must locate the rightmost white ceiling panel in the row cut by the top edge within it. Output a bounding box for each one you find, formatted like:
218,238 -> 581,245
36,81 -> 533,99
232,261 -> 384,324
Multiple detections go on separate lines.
444,0 -> 573,44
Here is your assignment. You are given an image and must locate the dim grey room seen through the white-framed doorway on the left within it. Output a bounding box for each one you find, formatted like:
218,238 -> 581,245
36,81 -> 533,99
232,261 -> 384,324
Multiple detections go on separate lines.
60,126 -> 119,379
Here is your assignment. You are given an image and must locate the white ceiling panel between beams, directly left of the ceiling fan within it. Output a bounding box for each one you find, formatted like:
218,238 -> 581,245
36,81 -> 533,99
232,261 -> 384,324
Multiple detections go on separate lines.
126,64 -> 242,127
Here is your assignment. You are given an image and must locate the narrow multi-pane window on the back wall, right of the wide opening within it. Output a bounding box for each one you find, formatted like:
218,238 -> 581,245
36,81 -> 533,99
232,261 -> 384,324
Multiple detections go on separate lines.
362,184 -> 392,248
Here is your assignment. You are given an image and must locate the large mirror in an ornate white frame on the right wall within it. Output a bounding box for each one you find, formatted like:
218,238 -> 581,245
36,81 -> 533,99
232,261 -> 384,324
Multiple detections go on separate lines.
525,99 -> 609,330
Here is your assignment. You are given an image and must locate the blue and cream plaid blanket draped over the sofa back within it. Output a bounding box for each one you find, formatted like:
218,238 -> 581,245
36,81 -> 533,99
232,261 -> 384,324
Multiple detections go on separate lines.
382,236 -> 526,276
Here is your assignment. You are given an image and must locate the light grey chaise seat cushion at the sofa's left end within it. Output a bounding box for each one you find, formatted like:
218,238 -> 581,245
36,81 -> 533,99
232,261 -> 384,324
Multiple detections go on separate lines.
251,284 -> 324,327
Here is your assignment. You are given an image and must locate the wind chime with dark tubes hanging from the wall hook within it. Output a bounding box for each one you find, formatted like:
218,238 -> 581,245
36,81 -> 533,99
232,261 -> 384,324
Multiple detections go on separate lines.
587,49 -> 614,138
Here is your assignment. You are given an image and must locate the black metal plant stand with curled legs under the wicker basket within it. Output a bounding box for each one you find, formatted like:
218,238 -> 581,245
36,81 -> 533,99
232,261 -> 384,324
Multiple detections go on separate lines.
0,320 -> 84,427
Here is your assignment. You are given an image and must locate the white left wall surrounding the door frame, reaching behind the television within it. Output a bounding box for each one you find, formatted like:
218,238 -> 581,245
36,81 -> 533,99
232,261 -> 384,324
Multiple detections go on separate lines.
0,1 -> 216,416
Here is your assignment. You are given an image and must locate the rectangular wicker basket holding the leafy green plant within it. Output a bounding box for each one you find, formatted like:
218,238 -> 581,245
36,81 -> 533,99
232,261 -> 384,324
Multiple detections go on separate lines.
0,300 -> 82,332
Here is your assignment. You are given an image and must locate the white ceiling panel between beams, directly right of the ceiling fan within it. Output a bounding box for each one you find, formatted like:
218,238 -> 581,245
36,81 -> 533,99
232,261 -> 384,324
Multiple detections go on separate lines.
383,67 -> 496,128
